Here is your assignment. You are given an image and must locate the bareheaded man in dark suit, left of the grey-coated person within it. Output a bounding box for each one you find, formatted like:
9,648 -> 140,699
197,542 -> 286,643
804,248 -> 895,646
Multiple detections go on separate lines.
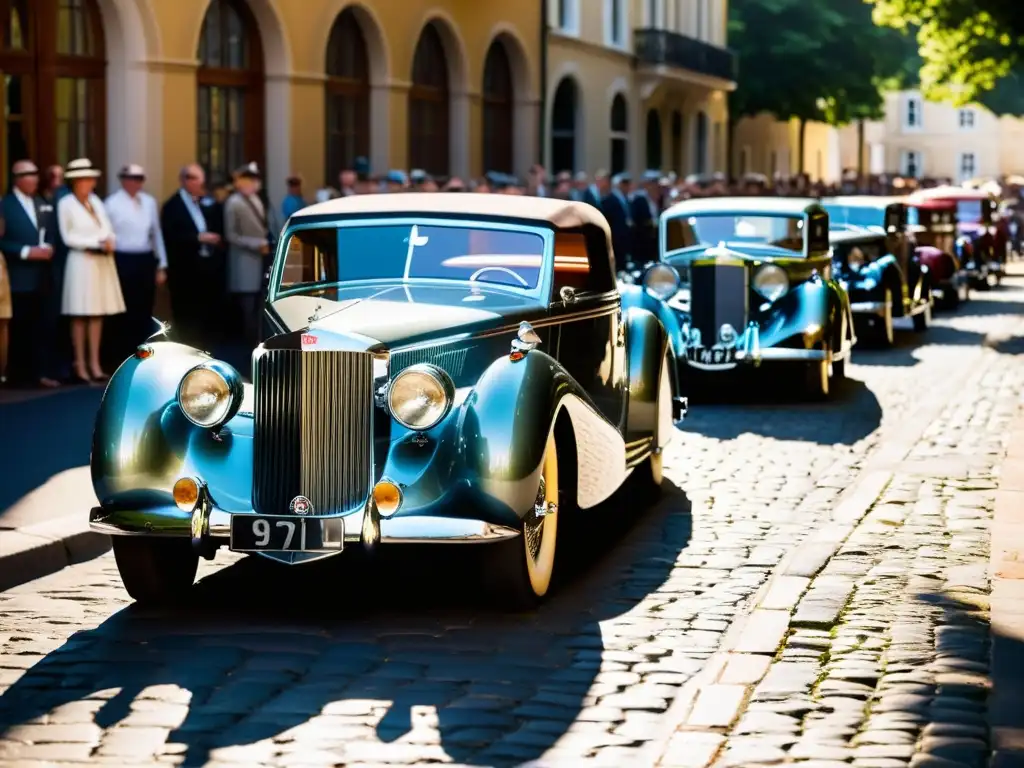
160,164 -> 223,344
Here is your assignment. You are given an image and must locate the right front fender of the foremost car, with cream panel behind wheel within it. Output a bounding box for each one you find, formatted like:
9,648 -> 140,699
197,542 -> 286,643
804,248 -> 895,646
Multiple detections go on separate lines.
462,349 -> 626,522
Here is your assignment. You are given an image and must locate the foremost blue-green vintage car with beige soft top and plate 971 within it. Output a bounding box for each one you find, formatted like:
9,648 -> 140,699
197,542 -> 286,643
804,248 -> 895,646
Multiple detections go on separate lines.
90,194 -> 685,606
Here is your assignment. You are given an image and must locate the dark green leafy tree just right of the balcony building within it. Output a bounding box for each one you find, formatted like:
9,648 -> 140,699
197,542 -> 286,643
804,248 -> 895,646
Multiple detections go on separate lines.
729,0 -> 916,171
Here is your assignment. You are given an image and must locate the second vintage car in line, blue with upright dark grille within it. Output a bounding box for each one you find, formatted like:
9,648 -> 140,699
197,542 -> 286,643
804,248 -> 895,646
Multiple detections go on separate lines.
623,197 -> 855,398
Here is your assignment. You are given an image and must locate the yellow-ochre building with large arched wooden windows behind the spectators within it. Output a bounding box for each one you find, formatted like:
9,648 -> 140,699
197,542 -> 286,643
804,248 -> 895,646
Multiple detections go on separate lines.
0,0 -> 544,201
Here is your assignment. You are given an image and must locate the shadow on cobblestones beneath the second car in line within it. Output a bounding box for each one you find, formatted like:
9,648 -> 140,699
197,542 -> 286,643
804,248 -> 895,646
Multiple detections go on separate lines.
683,379 -> 882,445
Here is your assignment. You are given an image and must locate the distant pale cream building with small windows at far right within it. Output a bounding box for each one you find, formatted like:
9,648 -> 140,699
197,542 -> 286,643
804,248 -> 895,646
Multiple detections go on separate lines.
880,91 -> 1024,181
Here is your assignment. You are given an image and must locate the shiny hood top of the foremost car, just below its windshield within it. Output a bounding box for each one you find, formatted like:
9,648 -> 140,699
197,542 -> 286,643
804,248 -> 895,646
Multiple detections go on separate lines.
272,285 -> 543,347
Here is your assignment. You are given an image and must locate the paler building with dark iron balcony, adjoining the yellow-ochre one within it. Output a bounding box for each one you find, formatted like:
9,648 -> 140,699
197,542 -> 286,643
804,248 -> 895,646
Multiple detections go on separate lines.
544,0 -> 737,174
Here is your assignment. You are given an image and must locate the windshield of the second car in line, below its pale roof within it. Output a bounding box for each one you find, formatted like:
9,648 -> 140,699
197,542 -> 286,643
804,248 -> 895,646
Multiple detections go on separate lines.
666,214 -> 805,254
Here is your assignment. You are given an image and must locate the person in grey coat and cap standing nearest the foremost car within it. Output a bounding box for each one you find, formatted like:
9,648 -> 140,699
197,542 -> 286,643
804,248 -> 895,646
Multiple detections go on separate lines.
224,163 -> 270,345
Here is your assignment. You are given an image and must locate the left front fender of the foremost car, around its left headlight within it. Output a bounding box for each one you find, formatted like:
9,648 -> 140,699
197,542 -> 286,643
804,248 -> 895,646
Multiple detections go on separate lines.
90,342 -> 252,518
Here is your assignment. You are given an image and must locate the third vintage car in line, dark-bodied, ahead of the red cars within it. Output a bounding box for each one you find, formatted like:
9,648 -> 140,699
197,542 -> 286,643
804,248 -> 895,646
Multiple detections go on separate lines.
821,196 -> 932,346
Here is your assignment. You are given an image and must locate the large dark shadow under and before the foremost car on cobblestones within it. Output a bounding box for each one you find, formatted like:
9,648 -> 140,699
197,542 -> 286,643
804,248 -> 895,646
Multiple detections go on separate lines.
0,482 -> 691,766
